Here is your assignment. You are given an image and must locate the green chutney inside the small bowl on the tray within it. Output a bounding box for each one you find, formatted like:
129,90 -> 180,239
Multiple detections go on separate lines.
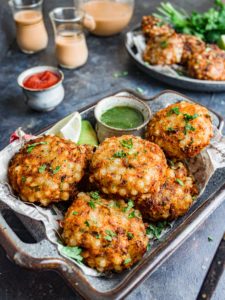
101,106 -> 144,129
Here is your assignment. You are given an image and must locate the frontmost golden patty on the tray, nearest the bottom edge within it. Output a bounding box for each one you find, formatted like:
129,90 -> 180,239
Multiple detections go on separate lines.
63,192 -> 148,272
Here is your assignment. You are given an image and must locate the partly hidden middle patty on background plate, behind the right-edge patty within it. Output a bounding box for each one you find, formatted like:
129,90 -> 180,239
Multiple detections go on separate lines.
182,34 -> 206,64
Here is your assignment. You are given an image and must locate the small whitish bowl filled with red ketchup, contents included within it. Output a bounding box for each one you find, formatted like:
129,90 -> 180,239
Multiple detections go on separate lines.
17,66 -> 64,111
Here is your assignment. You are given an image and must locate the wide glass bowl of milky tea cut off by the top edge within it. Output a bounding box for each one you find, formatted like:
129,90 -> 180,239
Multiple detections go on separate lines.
74,0 -> 135,36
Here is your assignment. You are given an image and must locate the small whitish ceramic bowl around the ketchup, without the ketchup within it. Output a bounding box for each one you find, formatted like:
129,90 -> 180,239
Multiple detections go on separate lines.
17,66 -> 65,111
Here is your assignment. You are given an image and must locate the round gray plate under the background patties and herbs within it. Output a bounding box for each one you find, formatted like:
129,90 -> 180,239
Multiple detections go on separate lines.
125,26 -> 225,92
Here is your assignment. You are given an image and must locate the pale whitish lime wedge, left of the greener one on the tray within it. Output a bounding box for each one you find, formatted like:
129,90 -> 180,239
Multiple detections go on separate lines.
46,112 -> 81,143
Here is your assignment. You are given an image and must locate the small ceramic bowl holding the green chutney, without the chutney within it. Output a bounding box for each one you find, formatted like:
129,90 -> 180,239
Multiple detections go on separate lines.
94,95 -> 151,142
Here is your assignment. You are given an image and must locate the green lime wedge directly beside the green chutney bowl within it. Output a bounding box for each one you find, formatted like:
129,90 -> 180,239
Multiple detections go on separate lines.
78,120 -> 98,146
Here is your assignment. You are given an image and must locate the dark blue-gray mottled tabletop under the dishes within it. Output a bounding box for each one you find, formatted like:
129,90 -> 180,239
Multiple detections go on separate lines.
0,0 -> 225,300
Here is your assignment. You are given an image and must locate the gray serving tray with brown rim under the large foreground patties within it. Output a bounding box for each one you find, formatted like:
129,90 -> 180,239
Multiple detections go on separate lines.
0,91 -> 225,300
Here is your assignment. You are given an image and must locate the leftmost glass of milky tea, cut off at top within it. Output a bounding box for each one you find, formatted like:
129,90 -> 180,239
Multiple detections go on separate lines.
9,0 -> 48,54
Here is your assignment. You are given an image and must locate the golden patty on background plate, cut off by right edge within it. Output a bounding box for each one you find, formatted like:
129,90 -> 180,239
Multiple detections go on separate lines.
188,45 -> 225,80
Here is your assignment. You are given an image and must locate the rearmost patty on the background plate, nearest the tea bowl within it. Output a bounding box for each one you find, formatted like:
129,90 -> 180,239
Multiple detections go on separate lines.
141,16 -> 174,39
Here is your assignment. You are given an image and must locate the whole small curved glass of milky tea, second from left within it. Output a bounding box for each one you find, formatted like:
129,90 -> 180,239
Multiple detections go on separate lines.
49,7 -> 88,69
